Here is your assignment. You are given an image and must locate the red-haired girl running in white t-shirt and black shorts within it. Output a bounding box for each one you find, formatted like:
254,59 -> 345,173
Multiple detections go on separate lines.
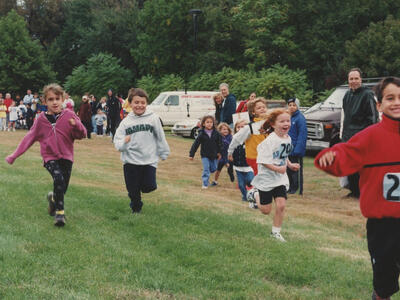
249,109 -> 300,242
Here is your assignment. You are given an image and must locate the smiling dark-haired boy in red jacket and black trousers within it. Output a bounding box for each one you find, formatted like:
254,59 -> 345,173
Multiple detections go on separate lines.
315,77 -> 400,299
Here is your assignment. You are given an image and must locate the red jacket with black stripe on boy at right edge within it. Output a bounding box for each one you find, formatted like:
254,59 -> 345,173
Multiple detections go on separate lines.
314,115 -> 400,219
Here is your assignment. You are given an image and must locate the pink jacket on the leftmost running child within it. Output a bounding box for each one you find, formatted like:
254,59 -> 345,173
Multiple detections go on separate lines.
6,109 -> 86,164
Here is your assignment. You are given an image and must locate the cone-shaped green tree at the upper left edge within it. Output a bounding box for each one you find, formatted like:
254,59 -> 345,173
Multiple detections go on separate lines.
0,10 -> 55,92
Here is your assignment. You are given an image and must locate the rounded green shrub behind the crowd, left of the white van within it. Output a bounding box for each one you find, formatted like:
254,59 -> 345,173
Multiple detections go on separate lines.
65,53 -> 132,98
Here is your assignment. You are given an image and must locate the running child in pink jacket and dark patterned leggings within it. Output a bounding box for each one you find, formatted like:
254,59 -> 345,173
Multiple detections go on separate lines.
6,83 -> 86,226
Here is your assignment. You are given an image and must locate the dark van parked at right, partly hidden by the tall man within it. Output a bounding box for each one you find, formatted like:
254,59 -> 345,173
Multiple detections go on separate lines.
303,78 -> 380,151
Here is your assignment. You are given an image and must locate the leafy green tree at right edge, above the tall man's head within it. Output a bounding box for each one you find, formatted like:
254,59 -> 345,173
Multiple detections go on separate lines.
342,16 -> 400,77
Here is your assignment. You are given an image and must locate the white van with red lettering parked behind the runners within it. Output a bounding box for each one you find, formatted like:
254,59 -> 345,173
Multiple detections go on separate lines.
148,91 -> 217,126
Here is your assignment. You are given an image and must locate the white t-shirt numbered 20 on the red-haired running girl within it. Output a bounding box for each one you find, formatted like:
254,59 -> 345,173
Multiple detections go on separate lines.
251,132 -> 293,192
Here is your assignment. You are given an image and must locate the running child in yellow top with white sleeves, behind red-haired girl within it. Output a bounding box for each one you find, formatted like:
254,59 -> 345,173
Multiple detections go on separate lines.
228,98 -> 267,175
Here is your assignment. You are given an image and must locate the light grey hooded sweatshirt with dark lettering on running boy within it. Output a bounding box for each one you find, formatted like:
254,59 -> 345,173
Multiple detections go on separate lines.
114,110 -> 170,167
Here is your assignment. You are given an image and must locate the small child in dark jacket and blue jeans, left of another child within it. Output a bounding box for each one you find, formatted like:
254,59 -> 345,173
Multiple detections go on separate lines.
189,116 -> 222,189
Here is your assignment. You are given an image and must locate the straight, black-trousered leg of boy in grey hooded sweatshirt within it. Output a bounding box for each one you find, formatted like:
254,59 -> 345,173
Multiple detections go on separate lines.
124,164 -> 143,212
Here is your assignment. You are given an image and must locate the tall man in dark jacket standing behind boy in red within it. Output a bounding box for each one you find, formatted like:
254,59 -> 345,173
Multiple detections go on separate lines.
340,68 -> 378,198
